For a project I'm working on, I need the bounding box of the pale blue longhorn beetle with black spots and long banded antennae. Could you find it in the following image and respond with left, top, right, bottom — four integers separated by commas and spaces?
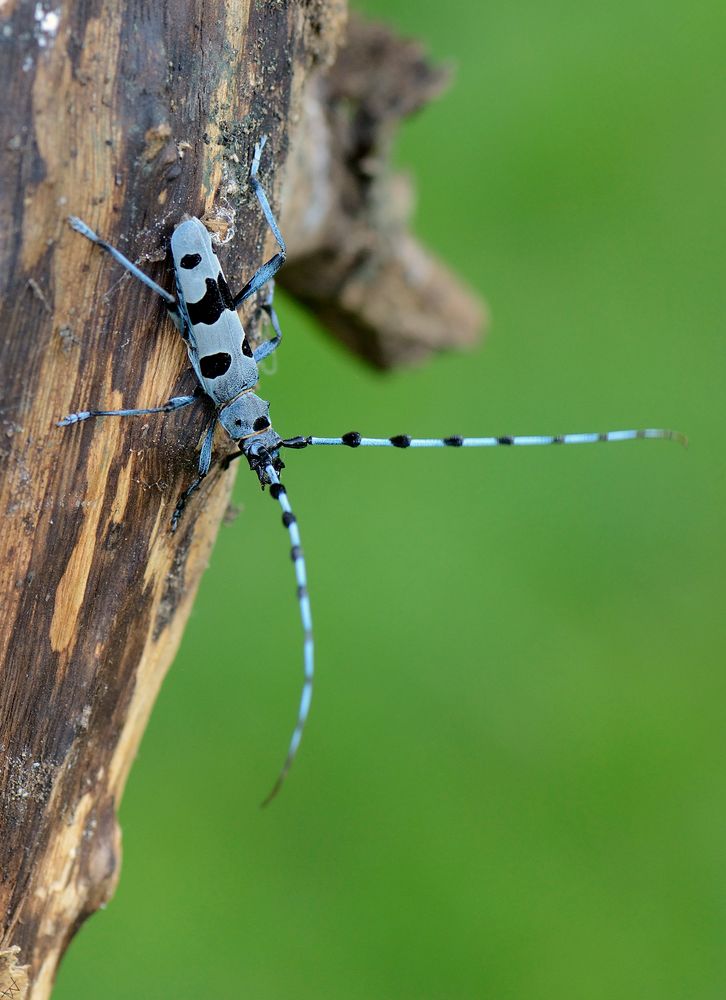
58, 136, 686, 805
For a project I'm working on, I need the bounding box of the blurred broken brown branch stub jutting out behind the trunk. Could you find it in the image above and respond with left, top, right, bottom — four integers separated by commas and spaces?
280, 17, 486, 368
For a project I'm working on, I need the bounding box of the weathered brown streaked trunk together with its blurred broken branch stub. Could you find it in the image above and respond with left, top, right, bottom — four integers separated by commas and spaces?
0, 0, 490, 1000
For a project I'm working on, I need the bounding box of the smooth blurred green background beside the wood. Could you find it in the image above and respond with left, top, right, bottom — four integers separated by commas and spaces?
55, 0, 726, 1000
